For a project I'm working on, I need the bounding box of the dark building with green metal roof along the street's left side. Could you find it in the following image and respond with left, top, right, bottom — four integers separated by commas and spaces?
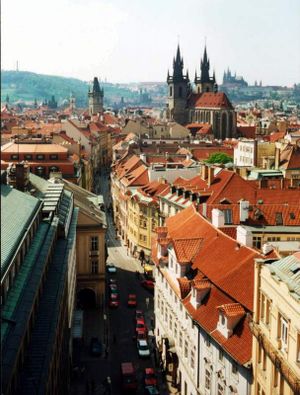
1, 169, 78, 394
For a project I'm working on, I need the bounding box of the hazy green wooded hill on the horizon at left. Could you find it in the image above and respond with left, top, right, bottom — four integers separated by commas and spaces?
1, 70, 137, 107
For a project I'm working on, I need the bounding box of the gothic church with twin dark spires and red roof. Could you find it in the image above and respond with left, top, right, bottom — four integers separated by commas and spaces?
167, 45, 236, 140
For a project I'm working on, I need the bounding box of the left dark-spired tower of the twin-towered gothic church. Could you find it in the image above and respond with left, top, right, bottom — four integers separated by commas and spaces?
167, 44, 191, 124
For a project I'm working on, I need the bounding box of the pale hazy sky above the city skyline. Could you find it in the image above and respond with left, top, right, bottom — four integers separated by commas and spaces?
1, 0, 300, 86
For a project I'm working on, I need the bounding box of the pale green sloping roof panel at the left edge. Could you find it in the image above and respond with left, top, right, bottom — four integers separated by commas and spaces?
1, 185, 41, 276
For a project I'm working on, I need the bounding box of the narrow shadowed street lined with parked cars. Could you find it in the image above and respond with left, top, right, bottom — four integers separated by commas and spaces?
71, 173, 166, 395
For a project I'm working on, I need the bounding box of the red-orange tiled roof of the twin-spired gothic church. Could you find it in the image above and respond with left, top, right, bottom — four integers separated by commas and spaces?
188, 92, 233, 110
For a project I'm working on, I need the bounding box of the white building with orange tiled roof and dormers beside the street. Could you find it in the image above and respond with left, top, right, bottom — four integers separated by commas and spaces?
152, 206, 261, 395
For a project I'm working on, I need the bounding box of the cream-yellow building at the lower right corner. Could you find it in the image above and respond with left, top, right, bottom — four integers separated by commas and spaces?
251, 253, 300, 395
